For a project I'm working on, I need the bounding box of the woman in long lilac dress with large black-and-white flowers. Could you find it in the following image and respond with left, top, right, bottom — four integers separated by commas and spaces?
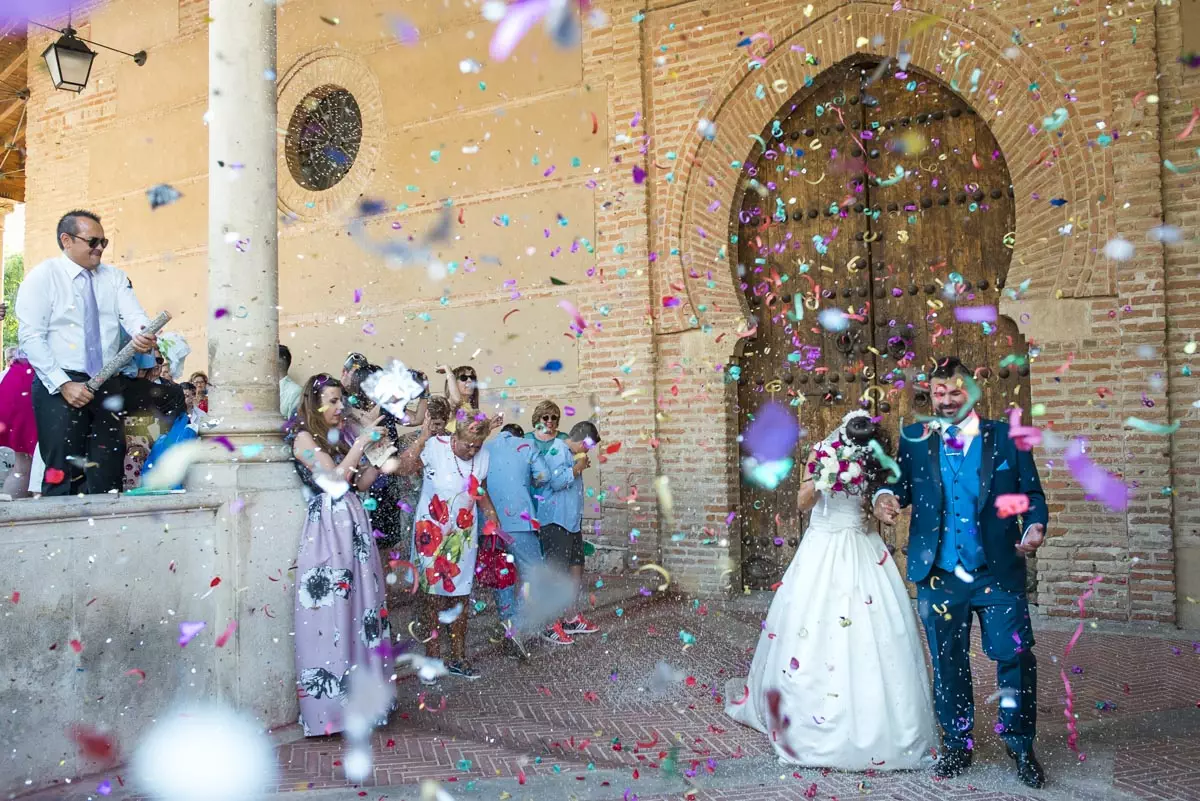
290, 374, 392, 737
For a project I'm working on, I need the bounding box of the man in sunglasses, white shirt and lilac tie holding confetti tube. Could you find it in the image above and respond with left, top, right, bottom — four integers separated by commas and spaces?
16, 210, 156, 495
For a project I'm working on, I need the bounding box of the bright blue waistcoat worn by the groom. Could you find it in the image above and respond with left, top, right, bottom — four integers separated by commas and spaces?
935, 435, 988, 572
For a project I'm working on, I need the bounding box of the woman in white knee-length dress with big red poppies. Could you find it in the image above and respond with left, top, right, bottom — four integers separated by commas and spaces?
397, 415, 498, 680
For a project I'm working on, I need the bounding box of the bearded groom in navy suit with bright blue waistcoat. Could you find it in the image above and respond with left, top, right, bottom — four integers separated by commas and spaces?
875, 357, 1048, 788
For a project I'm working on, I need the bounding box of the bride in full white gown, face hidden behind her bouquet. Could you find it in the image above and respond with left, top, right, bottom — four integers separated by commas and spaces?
725, 411, 937, 770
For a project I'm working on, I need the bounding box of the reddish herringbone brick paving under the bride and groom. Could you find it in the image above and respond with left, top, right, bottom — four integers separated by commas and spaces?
11, 588, 1200, 801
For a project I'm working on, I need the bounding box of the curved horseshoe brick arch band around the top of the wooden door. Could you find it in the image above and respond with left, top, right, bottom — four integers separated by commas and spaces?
660, 2, 1115, 359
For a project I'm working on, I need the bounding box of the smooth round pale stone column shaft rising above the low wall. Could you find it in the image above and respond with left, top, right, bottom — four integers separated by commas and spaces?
209, 0, 282, 450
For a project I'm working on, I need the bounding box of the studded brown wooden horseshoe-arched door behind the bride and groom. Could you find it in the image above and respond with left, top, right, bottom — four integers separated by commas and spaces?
731, 59, 1028, 589
